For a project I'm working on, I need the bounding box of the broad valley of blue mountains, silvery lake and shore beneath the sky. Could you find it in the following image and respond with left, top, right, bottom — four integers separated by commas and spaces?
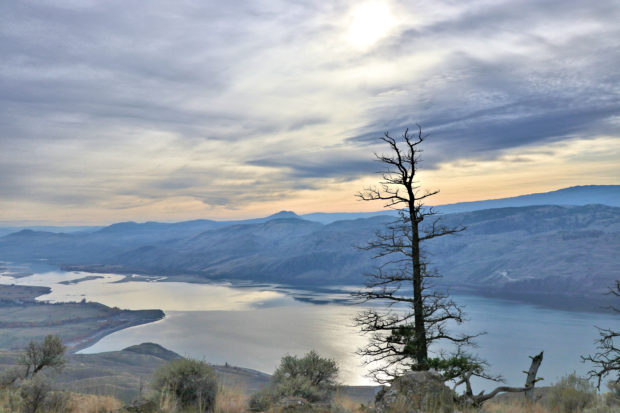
0, 188, 620, 408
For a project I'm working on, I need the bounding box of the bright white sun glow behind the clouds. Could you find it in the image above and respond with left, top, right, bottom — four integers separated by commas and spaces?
348, 1, 395, 49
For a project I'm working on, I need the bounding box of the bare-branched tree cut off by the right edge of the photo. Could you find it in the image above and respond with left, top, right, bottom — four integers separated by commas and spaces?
581, 280, 620, 390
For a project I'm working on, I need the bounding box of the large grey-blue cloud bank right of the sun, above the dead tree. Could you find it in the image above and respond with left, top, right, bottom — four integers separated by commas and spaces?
346, 1, 620, 160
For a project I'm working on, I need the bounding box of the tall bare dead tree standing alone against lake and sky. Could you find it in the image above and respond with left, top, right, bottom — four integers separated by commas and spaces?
353, 125, 482, 383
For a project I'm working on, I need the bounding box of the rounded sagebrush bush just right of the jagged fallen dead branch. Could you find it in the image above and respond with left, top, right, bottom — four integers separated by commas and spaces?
549, 373, 597, 413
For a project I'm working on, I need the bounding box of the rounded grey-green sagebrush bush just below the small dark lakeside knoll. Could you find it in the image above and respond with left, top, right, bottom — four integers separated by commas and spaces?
152, 359, 217, 412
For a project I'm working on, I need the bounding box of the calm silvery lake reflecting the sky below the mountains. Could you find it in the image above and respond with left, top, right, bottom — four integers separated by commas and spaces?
0, 264, 620, 390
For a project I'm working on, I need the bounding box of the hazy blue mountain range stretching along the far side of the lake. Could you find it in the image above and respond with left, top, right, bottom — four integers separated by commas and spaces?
0, 186, 620, 297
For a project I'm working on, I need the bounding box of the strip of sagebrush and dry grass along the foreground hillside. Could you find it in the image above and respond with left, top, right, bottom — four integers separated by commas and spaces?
0, 336, 620, 413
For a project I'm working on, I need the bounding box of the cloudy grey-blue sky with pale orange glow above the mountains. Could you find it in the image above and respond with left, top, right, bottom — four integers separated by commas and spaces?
0, 0, 620, 224
